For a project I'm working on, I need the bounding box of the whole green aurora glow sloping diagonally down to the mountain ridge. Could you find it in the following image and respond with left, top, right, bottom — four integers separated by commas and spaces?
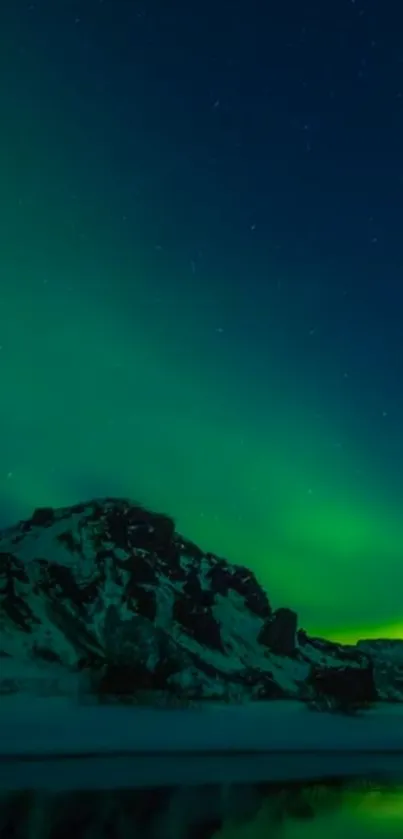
0, 4, 403, 640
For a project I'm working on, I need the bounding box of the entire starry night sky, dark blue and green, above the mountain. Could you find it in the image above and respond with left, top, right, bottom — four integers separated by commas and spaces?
0, 0, 403, 640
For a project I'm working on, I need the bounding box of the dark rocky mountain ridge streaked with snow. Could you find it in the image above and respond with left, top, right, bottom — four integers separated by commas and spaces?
0, 498, 403, 702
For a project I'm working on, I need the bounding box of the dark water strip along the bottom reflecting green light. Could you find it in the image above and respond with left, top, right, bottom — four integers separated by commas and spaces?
0, 780, 403, 839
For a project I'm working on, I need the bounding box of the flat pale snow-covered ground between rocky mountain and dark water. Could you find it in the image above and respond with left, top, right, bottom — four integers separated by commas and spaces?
0, 697, 403, 790
